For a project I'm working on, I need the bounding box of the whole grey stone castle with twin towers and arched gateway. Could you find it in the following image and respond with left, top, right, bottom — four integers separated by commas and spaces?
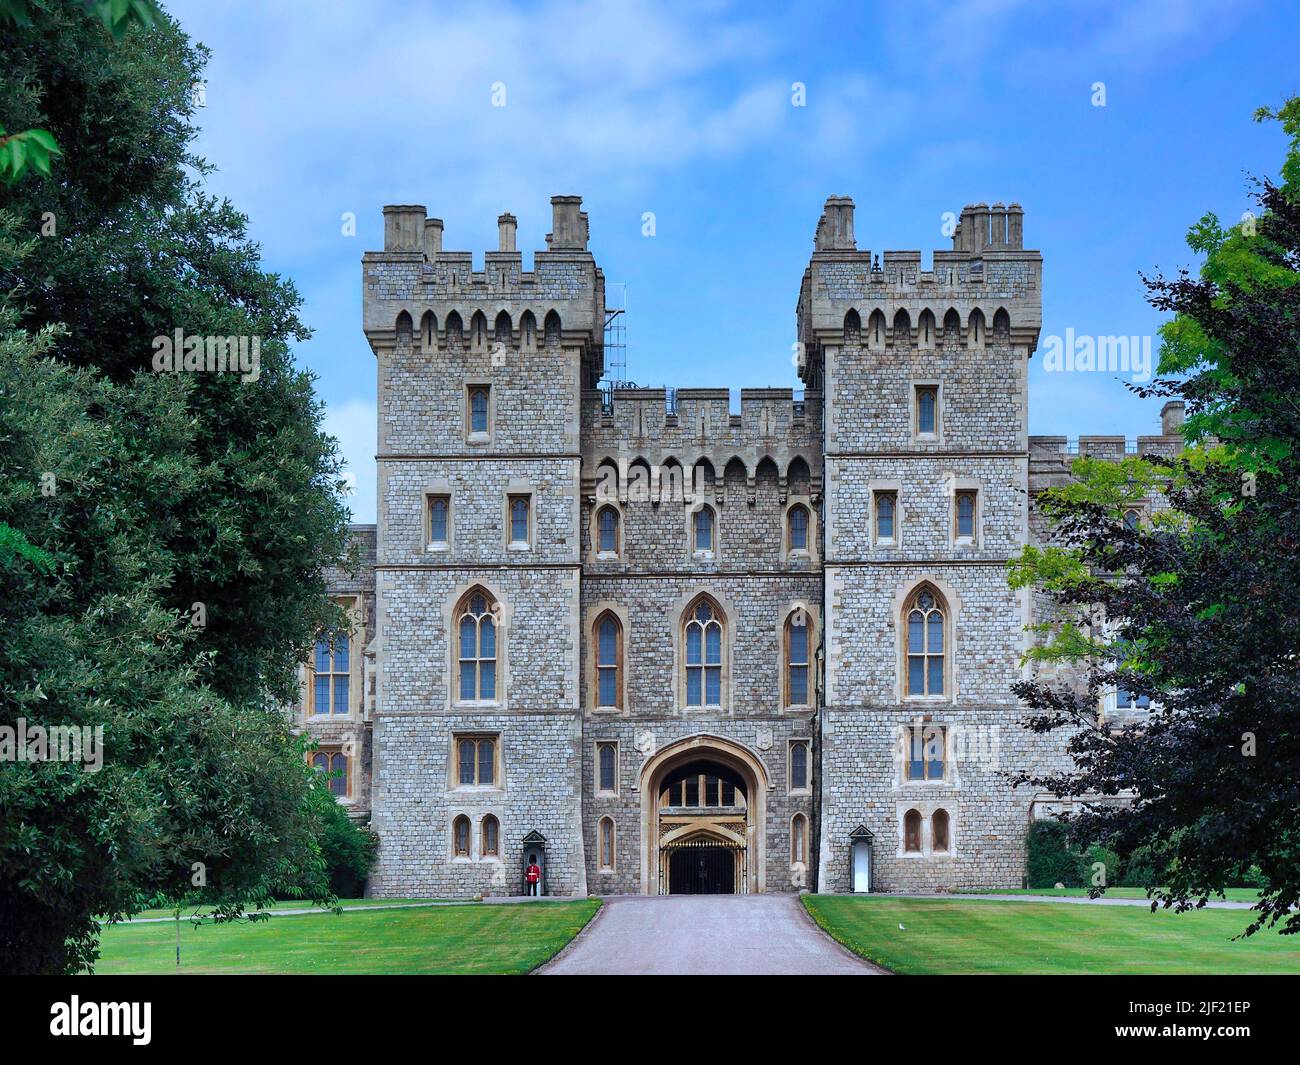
299, 196, 1182, 897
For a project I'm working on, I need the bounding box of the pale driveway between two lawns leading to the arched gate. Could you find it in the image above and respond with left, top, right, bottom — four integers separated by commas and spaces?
540, 895, 881, 975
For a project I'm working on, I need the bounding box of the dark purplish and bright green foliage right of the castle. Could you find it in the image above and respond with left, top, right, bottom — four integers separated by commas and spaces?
1010, 99, 1300, 932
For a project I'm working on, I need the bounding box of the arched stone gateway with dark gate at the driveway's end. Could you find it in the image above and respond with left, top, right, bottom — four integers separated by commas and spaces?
640, 736, 771, 895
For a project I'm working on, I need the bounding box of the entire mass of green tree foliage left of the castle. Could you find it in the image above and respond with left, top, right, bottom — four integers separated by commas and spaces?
0, 3, 347, 971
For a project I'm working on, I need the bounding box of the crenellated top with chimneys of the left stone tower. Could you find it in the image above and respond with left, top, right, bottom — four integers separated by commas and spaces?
361, 196, 605, 384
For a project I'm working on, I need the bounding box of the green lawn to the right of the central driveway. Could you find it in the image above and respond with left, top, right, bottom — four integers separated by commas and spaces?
803, 895, 1300, 974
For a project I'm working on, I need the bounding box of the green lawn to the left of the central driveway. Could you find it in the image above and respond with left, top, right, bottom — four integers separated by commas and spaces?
95, 899, 601, 974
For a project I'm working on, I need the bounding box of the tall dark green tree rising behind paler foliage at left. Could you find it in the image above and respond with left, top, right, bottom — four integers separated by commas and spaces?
0, 4, 347, 700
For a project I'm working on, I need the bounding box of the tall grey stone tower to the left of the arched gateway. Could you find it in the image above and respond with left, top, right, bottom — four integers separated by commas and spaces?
361, 196, 605, 896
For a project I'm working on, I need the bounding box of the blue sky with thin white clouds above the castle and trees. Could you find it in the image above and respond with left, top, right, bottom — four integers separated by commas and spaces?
164, 0, 1300, 521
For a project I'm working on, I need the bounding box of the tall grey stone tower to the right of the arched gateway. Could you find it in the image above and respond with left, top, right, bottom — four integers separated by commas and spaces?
798, 196, 1041, 891
